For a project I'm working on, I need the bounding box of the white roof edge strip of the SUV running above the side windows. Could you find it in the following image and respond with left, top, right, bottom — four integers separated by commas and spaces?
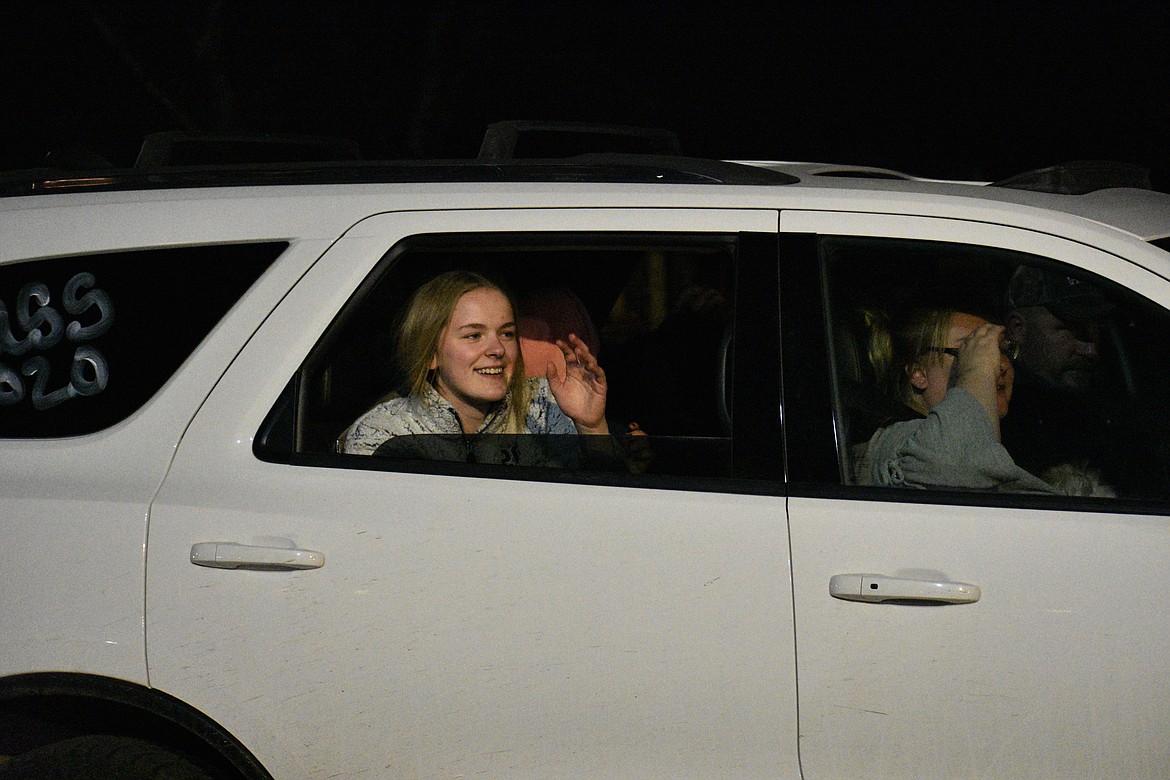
0, 177, 1170, 262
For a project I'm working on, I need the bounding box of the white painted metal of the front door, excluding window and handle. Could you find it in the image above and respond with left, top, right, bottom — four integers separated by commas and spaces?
780, 212, 1170, 778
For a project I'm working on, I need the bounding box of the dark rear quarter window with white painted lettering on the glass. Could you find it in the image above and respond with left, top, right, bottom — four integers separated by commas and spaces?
0, 242, 288, 439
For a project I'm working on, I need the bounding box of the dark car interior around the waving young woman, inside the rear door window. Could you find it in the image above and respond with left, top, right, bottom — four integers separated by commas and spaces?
261, 234, 735, 476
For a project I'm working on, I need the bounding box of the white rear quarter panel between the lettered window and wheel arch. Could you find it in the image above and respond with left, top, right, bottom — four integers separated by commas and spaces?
0, 229, 324, 684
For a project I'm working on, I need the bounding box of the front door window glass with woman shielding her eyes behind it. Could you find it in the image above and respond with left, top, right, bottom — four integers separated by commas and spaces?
821, 237, 1170, 501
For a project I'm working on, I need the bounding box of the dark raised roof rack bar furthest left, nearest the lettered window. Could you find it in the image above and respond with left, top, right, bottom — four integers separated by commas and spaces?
135, 131, 362, 170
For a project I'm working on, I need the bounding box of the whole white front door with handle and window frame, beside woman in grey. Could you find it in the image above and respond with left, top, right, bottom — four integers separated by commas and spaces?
782, 212, 1170, 778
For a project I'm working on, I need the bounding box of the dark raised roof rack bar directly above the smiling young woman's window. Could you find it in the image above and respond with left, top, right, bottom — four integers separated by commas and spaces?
477, 119, 682, 160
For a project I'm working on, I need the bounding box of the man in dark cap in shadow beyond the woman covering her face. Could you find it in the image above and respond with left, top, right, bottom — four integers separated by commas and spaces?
1002, 265, 1166, 497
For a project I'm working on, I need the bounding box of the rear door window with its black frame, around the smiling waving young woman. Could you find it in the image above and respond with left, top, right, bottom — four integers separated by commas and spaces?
256, 234, 775, 484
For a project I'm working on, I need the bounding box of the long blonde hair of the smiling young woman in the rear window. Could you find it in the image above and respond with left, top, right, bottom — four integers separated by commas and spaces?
398, 270, 529, 434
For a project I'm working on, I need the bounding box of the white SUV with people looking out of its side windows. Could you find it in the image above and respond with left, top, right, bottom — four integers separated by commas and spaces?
0, 132, 1170, 779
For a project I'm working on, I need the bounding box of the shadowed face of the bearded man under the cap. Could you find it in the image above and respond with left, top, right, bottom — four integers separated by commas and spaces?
1007, 306, 1101, 389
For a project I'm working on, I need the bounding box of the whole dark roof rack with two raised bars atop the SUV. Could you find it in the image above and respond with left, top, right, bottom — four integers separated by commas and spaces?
0, 122, 799, 196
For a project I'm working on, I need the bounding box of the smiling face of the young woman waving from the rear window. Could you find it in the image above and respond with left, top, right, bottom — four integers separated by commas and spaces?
431, 288, 519, 417
